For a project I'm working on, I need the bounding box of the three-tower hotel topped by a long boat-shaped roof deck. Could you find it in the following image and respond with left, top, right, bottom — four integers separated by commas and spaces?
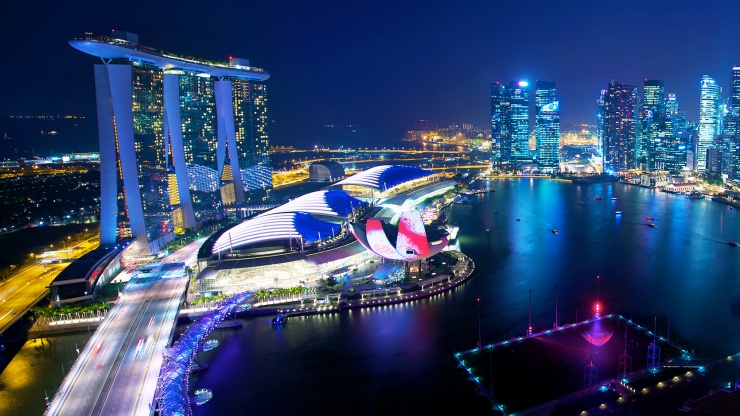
69, 31, 272, 254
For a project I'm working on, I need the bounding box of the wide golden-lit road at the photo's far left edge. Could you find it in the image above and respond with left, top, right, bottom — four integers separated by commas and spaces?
0, 236, 98, 334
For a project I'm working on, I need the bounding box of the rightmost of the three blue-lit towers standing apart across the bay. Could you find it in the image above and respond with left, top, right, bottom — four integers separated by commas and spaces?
535, 81, 560, 173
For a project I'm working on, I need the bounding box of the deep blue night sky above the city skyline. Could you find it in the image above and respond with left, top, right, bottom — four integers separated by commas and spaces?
0, 0, 740, 147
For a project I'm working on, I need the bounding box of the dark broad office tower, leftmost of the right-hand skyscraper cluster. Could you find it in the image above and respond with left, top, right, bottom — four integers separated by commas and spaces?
601, 81, 637, 174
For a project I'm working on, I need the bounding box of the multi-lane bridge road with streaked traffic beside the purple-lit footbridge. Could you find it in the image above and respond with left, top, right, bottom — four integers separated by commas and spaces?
47, 239, 205, 415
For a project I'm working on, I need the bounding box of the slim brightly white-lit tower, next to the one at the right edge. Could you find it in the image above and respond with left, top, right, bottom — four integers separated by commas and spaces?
696, 75, 721, 173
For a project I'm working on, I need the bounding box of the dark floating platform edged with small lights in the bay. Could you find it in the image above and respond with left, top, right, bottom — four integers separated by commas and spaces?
455, 315, 704, 415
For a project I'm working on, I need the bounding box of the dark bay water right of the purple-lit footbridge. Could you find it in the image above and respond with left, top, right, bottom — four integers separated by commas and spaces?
190, 179, 740, 415
